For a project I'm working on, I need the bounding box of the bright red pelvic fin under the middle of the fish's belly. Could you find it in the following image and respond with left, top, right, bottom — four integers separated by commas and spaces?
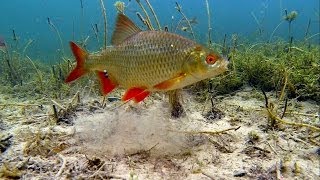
122, 87, 150, 103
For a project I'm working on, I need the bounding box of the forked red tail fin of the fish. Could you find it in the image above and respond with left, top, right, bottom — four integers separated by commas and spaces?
65, 41, 88, 83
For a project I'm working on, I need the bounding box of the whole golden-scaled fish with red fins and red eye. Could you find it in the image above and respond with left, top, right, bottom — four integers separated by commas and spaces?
65, 13, 228, 103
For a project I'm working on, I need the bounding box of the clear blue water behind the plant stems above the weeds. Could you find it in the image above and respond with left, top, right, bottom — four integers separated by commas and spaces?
0, 0, 320, 63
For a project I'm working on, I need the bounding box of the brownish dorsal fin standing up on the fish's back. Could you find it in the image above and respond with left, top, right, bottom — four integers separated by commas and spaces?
111, 13, 141, 45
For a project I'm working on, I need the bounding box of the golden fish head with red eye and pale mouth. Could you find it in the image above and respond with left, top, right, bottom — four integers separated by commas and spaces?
183, 46, 229, 83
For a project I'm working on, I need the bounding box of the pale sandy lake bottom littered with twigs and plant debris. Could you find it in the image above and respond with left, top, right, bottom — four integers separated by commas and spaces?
0, 87, 320, 179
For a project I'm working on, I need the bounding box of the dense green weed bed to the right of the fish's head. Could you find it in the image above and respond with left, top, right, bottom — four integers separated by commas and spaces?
191, 38, 320, 102
